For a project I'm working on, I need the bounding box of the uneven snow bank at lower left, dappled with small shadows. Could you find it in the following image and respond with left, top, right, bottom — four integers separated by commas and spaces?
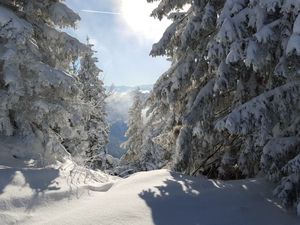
0, 156, 118, 225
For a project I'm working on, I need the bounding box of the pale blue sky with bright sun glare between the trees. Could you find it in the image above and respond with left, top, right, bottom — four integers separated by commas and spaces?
66, 0, 170, 86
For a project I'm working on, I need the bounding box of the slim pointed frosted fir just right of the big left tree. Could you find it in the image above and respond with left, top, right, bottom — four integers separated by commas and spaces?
78, 39, 108, 168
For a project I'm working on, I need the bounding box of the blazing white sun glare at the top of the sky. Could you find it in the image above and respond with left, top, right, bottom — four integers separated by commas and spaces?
118, 0, 170, 43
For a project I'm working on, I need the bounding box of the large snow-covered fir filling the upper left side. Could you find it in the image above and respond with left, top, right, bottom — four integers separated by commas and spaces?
0, 0, 106, 165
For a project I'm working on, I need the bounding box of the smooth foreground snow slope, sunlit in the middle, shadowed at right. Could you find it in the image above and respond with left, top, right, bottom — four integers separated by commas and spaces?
0, 168, 300, 225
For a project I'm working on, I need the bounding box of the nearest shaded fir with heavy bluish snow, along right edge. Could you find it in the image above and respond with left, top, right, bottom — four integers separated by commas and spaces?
210, 1, 300, 209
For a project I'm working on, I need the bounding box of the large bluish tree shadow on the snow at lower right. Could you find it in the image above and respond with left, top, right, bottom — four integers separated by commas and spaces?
139, 173, 299, 225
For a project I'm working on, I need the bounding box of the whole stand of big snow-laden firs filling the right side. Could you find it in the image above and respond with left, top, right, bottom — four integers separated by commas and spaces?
120, 0, 300, 211
